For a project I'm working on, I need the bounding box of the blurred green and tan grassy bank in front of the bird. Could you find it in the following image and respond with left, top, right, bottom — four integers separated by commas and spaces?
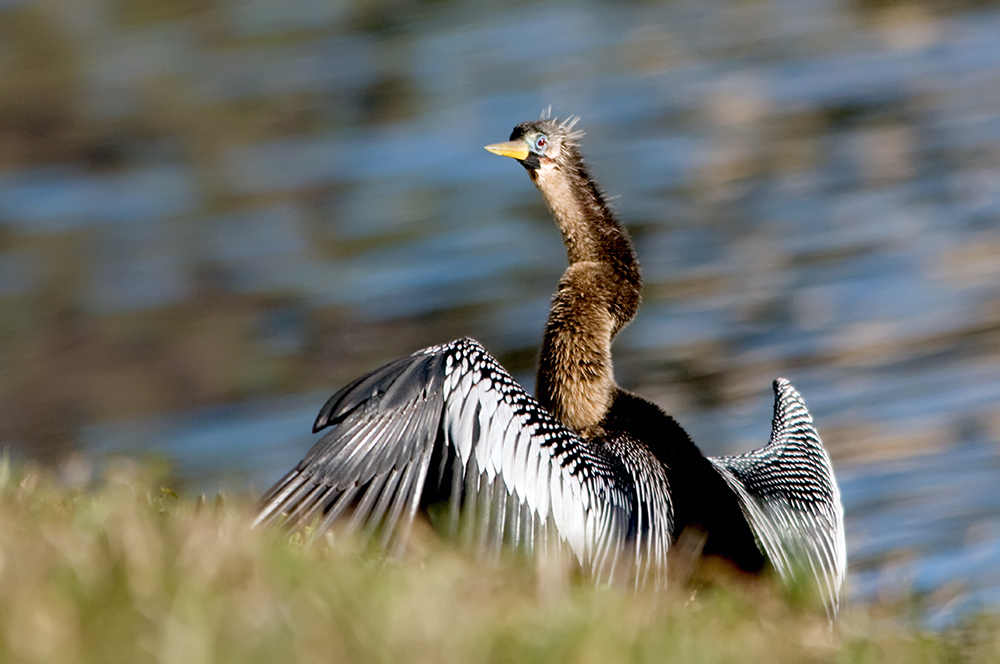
0, 456, 1000, 664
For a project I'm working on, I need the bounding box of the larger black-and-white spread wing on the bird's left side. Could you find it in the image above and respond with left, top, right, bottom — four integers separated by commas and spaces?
254, 339, 672, 578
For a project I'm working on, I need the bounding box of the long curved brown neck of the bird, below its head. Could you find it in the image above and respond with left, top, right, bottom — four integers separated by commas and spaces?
531, 153, 642, 434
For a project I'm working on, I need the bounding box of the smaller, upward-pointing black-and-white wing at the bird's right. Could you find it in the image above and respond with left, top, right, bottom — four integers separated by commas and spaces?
709, 378, 847, 617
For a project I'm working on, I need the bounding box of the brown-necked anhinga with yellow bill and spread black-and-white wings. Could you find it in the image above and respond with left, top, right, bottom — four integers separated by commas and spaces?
254, 114, 847, 619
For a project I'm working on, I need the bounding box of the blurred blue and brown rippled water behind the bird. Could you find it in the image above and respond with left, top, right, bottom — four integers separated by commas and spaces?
0, 0, 1000, 624
